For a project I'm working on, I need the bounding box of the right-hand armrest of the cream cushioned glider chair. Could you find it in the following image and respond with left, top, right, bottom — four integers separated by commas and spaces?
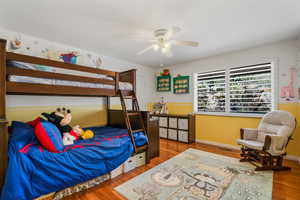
263, 135, 287, 155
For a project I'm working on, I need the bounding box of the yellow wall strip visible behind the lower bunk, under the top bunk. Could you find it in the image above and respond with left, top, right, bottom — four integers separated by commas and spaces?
6, 105, 107, 127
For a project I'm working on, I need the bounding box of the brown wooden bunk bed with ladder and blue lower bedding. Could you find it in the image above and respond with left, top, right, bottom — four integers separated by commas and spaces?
0, 39, 149, 199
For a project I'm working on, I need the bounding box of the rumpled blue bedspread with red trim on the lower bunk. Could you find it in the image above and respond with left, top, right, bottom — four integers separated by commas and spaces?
1, 124, 147, 200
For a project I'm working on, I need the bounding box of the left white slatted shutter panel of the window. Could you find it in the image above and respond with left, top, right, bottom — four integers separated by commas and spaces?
196, 70, 225, 112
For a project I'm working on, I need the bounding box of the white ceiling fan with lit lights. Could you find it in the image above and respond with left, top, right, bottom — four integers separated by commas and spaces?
137, 27, 199, 57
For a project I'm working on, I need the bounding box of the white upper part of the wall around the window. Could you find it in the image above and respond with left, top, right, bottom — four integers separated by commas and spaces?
156, 40, 298, 103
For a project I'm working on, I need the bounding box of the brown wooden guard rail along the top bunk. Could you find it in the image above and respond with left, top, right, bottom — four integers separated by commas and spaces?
0, 40, 136, 96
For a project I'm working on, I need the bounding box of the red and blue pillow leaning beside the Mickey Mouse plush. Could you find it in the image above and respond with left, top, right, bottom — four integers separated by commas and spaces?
34, 119, 64, 153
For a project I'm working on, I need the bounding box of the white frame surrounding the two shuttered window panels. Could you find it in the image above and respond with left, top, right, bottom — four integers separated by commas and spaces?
193, 61, 279, 118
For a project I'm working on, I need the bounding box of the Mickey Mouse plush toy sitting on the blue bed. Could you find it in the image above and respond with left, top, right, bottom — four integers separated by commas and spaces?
42, 108, 94, 145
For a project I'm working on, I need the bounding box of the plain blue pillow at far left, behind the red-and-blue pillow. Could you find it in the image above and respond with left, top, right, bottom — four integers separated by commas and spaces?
9, 121, 38, 151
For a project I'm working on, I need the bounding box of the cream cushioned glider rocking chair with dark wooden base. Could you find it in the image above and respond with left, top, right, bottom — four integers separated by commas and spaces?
237, 111, 296, 170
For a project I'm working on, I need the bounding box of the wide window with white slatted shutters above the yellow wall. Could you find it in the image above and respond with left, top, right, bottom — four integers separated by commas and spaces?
195, 63, 274, 114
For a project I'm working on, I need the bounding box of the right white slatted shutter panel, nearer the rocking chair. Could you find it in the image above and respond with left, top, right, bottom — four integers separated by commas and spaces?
229, 63, 272, 113
